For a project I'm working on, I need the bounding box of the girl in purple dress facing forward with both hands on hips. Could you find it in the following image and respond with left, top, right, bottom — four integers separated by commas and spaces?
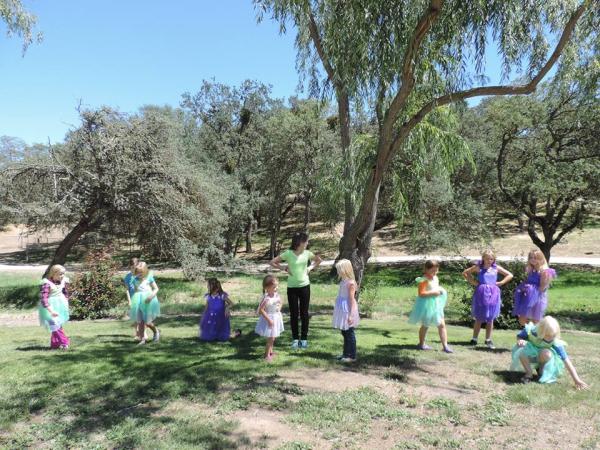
463, 250, 513, 349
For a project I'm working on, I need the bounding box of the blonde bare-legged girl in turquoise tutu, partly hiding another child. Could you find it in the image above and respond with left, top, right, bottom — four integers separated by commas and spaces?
129, 261, 160, 345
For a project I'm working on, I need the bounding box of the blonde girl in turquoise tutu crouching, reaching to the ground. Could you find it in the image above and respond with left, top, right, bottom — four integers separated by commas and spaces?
511, 316, 588, 390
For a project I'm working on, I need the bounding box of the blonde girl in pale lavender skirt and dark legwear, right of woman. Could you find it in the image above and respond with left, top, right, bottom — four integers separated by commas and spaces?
333, 259, 359, 362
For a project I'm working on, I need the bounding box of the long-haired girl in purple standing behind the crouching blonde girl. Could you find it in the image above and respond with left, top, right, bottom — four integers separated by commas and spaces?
513, 249, 556, 326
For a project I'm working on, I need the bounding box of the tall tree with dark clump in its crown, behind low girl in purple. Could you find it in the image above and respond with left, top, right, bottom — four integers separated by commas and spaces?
181, 80, 282, 256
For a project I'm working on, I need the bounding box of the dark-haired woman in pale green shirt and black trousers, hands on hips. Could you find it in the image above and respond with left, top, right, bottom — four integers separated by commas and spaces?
271, 233, 321, 348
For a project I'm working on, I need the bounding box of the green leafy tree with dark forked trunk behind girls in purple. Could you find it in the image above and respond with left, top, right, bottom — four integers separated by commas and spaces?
490, 88, 600, 260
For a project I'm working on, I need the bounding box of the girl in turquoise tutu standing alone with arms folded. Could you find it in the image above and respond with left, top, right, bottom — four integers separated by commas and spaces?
408, 260, 454, 353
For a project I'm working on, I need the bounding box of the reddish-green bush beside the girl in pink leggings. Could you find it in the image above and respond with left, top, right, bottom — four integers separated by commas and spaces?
69, 249, 124, 320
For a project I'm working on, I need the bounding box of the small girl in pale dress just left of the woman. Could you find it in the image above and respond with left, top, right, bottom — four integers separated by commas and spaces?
254, 275, 283, 362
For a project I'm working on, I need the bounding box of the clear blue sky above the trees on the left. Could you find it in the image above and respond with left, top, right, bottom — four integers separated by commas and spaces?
0, 0, 516, 144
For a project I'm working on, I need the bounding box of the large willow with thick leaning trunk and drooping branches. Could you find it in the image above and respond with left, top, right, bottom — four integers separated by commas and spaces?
254, 0, 599, 280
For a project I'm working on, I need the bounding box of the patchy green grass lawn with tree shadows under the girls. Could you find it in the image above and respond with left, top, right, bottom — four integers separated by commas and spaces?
0, 269, 600, 449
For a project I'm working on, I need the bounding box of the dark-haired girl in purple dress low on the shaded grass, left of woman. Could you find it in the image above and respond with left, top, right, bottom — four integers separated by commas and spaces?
200, 278, 233, 342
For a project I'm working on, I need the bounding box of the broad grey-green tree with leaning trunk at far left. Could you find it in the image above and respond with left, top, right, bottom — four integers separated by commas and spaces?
0, 108, 226, 274
